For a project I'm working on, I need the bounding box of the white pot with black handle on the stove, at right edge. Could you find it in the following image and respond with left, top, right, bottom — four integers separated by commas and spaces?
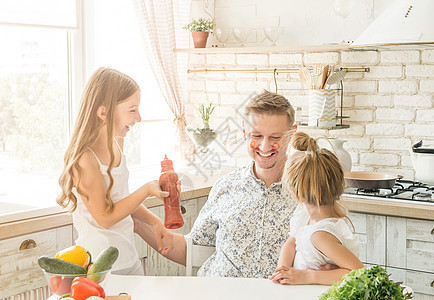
410, 141, 434, 185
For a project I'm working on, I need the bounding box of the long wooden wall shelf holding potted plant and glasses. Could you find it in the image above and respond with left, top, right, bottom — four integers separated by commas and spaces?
173, 44, 351, 54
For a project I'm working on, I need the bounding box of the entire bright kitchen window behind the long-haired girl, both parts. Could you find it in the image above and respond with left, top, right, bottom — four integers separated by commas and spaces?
0, 0, 177, 223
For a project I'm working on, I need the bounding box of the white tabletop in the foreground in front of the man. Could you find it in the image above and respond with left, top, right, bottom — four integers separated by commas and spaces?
104, 274, 330, 300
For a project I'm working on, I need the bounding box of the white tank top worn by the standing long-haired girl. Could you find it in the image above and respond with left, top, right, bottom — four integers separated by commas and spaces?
72, 140, 139, 271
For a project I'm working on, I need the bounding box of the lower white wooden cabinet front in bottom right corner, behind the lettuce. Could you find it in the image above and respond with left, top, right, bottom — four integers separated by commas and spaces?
386, 267, 434, 300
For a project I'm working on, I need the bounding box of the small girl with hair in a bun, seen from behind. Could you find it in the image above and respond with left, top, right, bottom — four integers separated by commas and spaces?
270, 132, 363, 285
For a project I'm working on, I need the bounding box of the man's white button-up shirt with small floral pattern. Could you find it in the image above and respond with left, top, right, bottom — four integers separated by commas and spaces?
188, 164, 297, 278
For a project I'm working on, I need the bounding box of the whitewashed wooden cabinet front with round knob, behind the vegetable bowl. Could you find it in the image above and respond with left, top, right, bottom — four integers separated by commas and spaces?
0, 225, 72, 299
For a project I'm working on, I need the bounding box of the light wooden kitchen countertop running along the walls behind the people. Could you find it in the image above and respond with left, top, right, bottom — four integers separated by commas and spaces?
0, 169, 434, 240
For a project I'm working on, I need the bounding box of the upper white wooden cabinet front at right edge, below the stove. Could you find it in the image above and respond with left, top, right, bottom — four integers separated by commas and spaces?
387, 217, 434, 273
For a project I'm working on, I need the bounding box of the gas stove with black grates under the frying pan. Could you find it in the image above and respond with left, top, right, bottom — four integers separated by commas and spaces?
343, 179, 434, 204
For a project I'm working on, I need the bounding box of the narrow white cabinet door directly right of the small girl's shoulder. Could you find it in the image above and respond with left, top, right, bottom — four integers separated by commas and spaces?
349, 213, 386, 266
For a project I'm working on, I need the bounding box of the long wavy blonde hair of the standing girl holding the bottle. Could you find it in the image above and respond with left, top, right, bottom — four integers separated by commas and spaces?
57, 67, 139, 212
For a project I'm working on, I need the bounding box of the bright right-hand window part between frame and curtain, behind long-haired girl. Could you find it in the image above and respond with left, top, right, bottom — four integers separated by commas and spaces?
86, 0, 177, 190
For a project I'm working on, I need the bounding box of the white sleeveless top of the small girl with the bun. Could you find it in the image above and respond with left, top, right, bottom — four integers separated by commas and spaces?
290, 203, 359, 270
